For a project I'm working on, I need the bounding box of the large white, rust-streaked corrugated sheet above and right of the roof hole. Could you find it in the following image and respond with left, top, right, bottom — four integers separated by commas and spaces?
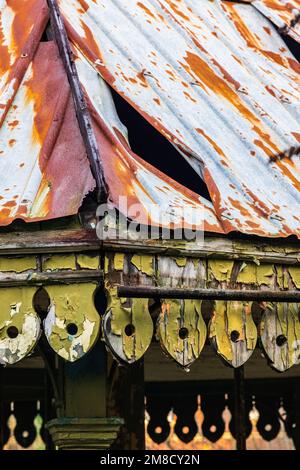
59, 0, 300, 236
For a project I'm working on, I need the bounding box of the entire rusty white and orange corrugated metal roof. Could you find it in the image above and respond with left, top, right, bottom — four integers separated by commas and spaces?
0, 0, 300, 236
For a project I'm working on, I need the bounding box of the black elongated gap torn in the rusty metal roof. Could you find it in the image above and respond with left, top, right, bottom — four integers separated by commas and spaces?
111, 89, 211, 201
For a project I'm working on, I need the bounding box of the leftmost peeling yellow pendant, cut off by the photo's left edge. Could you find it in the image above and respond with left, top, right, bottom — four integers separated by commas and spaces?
0, 287, 40, 364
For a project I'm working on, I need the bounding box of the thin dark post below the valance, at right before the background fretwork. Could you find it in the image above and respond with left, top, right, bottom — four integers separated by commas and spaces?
234, 366, 246, 450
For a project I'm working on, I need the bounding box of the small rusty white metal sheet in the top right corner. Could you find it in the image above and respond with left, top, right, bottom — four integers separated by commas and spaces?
252, 0, 300, 42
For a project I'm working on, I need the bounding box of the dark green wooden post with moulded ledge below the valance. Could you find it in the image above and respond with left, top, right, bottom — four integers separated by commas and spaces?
47, 342, 122, 450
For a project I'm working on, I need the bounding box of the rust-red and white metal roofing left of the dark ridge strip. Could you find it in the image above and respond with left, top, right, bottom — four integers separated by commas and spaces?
0, 0, 94, 225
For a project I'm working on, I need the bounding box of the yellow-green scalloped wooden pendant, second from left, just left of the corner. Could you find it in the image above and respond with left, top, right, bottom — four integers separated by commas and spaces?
44, 283, 100, 362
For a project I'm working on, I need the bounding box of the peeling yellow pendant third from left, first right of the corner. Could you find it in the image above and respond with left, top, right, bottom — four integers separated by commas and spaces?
102, 289, 153, 364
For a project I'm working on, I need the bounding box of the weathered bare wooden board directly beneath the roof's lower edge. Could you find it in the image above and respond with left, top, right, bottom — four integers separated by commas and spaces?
0, 228, 300, 265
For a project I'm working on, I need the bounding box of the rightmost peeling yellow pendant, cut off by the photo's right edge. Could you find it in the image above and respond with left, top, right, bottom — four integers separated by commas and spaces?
260, 303, 300, 372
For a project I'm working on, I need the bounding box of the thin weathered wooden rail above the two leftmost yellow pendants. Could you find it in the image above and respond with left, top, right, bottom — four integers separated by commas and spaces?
0, 269, 103, 287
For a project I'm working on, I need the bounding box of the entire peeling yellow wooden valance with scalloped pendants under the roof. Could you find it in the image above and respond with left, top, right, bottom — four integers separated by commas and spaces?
0, 233, 300, 371
